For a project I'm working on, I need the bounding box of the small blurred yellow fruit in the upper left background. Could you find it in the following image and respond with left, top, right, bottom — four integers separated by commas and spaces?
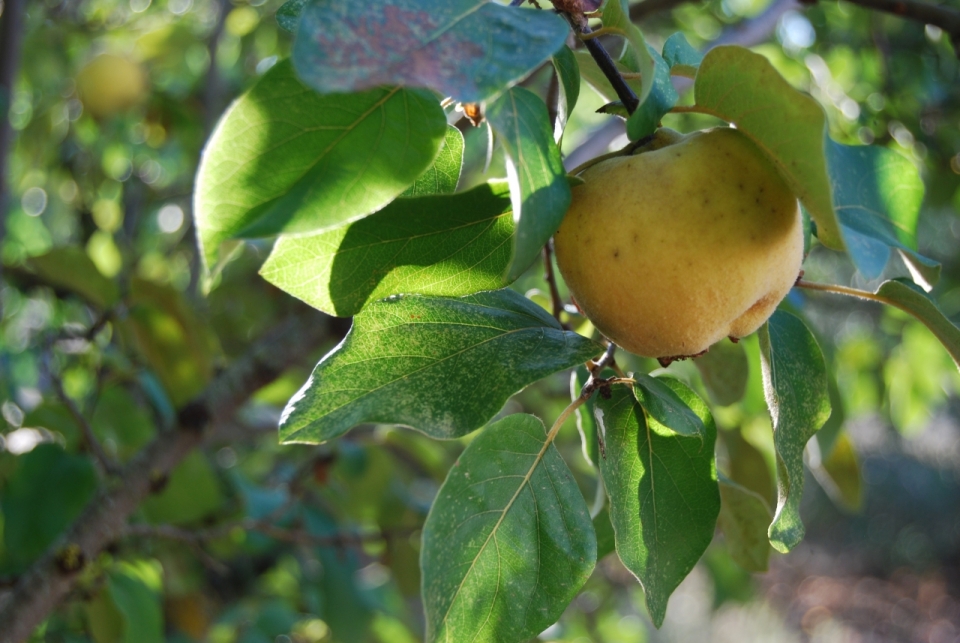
77, 54, 147, 118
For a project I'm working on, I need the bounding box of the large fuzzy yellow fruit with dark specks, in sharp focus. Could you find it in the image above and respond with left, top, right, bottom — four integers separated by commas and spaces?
554, 128, 803, 358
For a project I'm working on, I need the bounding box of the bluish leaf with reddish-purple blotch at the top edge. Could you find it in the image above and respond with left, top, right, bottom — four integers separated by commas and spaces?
293, 0, 570, 103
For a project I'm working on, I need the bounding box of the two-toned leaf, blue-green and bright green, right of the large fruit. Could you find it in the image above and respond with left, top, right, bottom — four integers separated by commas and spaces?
825, 139, 940, 290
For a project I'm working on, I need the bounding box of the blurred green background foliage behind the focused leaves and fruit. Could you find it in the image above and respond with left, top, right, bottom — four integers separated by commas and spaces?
0, 0, 960, 643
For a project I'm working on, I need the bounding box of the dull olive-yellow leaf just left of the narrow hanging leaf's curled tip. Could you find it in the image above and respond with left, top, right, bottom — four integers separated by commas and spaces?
717, 475, 773, 572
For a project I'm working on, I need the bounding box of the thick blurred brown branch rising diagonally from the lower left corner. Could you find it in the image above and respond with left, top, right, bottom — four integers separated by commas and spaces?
0, 313, 340, 643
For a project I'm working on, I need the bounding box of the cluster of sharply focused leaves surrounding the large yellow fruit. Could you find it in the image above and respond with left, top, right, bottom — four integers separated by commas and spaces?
189, 0, 960, 641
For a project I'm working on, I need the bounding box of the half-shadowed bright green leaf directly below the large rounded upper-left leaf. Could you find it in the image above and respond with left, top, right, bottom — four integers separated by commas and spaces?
260, 181, 513, 317
